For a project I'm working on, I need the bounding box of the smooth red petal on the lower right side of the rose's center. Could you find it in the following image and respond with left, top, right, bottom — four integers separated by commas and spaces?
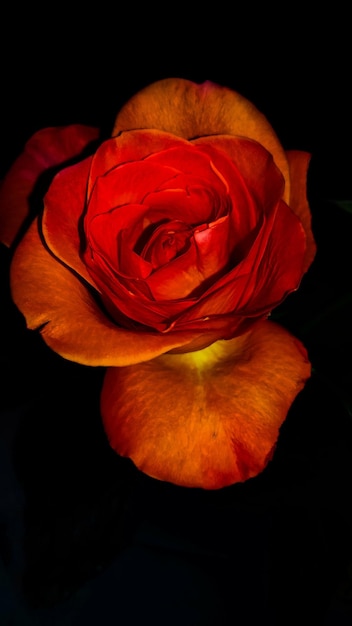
177, 202, 305, 327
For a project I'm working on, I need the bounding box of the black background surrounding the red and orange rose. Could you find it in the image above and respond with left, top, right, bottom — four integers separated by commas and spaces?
0, 11, 352, 626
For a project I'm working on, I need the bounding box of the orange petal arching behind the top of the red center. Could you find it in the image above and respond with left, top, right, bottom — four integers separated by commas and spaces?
112, 78, 290, 201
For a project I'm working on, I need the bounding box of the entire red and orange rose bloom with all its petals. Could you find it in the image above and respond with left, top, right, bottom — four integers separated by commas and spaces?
0, 79, 315, 489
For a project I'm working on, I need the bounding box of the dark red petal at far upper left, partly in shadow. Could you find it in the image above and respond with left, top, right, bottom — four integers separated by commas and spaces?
0, 124, 99, 246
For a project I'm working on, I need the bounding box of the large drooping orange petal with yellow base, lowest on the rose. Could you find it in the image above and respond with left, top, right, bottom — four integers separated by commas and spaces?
101, 321, 310, 489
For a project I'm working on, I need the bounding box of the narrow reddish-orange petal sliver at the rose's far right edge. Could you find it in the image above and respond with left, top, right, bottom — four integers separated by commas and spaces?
286, 150, 316, 271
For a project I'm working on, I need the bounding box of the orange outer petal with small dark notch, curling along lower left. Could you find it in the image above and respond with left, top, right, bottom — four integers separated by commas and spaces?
11, 220, 221, 366
